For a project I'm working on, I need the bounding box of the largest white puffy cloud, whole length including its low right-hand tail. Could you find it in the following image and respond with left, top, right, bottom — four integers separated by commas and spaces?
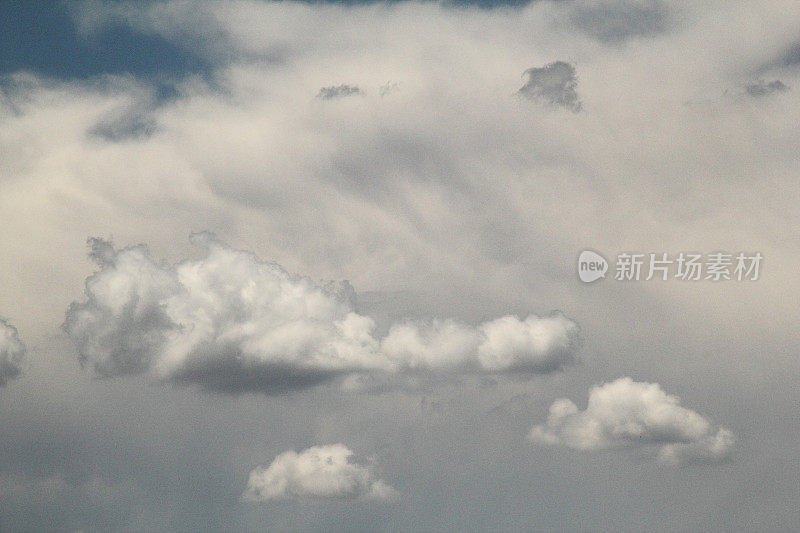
64, 233, 580, 393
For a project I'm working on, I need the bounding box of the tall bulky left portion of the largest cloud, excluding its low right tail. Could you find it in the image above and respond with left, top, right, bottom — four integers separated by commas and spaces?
64, 234, 390, 391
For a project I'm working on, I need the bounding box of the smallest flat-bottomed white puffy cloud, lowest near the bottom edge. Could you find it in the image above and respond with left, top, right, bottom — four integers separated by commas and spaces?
242, 444, 397, 502
